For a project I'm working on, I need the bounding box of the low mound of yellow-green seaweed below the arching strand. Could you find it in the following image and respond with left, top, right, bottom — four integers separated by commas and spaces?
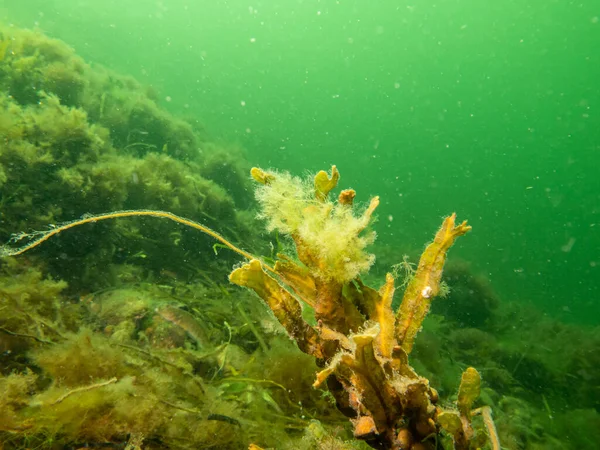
0, 259, 354, 449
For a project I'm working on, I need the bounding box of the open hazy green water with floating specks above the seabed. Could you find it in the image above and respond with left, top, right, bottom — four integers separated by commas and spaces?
0, 0, 600, 324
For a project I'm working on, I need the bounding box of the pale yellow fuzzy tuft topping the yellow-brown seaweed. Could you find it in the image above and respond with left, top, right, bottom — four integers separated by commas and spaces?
252, 167, 379, 283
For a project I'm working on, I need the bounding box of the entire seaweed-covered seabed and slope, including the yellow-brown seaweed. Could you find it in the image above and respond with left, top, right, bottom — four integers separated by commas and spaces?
0, 22, 600, 450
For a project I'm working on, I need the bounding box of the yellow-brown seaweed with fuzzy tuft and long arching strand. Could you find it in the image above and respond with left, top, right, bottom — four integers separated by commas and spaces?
2, 166, 498, 450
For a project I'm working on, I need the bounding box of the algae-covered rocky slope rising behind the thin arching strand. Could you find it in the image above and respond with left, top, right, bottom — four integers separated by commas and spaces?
0, 27, 253, 289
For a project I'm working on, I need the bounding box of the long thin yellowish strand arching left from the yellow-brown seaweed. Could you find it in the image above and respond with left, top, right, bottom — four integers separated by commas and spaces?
0, 209, 275, 272
